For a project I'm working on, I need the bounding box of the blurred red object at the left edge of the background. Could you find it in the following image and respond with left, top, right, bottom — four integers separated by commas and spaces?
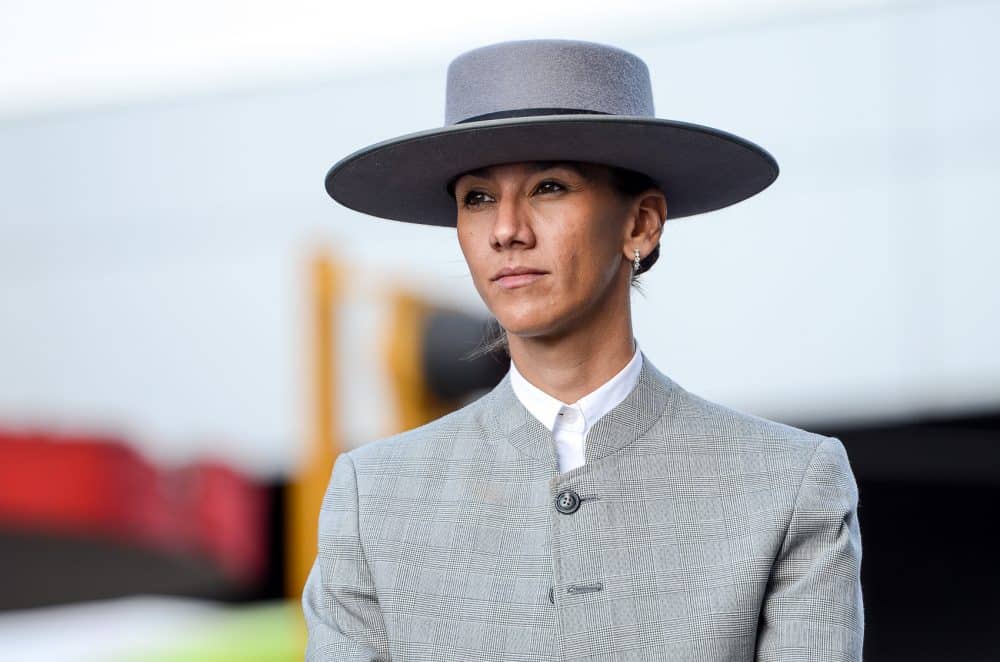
0, 429, 268, 583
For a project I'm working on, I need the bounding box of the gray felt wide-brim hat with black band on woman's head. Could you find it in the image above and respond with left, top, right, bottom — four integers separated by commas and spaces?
326, 39, 778, 226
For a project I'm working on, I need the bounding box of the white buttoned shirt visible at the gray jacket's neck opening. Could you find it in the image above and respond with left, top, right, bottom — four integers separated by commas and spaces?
510, 342, 642, 472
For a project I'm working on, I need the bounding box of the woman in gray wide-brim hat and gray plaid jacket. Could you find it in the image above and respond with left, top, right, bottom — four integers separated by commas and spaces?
303, 40, 864, 662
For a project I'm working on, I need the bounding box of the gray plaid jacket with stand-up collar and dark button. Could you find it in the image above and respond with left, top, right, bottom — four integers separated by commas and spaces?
302, 355, 864, 662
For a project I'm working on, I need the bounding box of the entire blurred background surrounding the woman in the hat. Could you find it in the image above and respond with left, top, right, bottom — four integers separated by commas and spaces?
0, 0, 1000, 662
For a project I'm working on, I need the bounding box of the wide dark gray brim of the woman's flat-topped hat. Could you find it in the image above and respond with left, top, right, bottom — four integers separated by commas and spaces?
326, 115, 778, 227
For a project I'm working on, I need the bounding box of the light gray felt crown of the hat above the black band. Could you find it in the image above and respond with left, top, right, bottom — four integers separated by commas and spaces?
445, 39, 654, 125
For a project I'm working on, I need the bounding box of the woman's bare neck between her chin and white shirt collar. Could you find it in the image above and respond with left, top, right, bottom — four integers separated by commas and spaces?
508, 316, 635, 404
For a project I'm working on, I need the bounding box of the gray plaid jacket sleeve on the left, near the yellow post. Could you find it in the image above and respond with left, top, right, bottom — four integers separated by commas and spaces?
302, 453, 389, 662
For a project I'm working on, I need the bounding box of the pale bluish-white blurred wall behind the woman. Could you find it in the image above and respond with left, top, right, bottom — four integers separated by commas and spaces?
0, 1, 1000, 473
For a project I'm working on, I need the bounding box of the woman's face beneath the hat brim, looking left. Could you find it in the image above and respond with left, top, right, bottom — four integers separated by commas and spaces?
455, 162, 631, 337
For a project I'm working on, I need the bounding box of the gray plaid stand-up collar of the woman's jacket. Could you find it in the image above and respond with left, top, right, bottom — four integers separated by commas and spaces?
484, 353, 680, 470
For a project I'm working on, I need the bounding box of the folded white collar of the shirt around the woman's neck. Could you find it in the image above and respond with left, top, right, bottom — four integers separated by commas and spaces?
510, 342, 642, 430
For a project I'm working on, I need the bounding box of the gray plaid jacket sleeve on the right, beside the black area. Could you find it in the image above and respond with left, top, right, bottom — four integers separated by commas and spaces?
756, 437, 864, 662
